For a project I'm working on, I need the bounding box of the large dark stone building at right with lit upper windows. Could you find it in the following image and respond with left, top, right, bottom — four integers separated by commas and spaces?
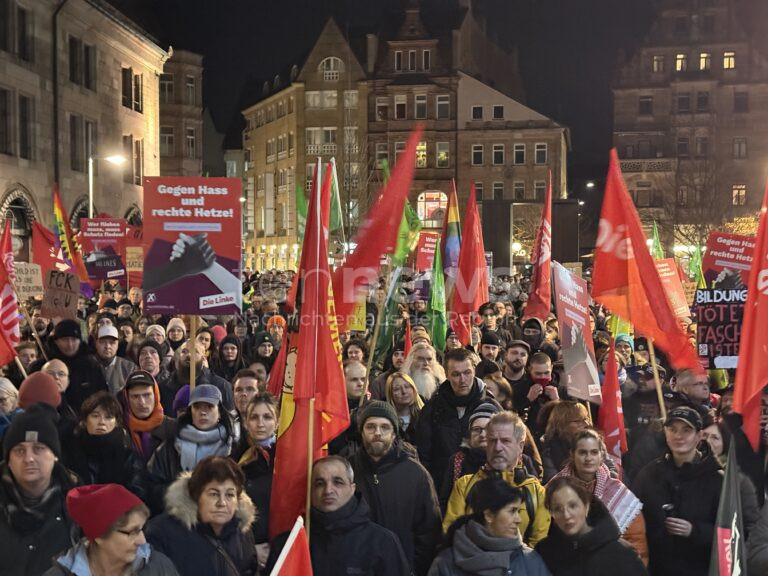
613, 0, 768, 251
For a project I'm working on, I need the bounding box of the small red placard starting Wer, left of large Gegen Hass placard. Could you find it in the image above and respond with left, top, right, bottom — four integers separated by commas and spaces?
80, 218, 126, 280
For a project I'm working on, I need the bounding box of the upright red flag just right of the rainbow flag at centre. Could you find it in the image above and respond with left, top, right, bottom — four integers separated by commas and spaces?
451, 184, 490, 346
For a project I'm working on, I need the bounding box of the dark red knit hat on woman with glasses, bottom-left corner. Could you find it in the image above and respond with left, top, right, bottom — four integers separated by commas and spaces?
67, 484, 144, 540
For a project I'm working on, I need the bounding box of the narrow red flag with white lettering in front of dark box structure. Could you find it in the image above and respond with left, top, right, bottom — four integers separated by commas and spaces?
523, 172, 552, 320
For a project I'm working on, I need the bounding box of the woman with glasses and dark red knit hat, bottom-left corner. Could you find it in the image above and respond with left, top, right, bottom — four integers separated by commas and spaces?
44, 484, 178, 576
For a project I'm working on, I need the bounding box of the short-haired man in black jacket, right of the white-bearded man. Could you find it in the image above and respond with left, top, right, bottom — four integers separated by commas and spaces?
416, 348, 490, 486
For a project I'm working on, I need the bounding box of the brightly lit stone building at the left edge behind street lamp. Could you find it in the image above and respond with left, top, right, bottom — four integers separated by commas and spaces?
0, 0, 169, 260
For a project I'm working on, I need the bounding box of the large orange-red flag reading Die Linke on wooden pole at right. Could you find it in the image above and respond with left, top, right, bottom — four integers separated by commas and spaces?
592, 149, 701, 372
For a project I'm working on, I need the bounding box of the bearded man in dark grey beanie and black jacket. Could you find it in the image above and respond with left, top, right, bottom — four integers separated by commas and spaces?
352, 400, 441, 576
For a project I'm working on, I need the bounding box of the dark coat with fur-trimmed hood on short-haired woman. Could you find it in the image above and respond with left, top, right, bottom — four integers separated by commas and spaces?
145, 472, 256, 576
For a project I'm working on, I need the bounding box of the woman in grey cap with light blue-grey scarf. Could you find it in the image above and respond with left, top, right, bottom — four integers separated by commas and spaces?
147, 384, 233, 511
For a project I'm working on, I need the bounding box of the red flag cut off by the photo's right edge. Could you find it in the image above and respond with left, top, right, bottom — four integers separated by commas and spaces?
733, 188, 768, 450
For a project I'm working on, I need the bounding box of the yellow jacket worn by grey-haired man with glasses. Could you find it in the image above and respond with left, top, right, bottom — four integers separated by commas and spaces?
443, 466, 550, 546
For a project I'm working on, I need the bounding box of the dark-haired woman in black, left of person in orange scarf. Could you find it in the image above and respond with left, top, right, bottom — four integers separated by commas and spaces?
62, 391, 149, 500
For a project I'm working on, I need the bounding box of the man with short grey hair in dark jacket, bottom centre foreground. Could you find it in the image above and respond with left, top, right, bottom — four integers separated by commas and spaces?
261, 456, 411, 576
